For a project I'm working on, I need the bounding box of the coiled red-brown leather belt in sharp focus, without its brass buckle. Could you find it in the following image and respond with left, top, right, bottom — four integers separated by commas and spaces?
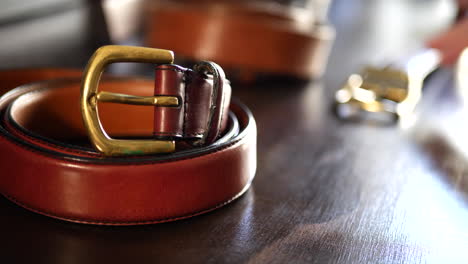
0, 46, 256, 225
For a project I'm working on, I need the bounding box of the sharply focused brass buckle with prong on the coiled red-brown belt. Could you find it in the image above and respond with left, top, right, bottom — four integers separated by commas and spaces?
80, 46, 180, 156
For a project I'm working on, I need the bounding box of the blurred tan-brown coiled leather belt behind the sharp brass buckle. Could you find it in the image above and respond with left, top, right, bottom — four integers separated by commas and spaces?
145, 0, 334, 79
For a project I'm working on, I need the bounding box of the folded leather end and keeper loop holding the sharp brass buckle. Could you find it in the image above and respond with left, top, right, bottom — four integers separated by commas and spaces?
154, 65, 231, 143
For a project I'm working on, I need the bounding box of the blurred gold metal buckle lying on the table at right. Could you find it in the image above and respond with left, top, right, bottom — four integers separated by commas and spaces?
335, 49, 440, 120
